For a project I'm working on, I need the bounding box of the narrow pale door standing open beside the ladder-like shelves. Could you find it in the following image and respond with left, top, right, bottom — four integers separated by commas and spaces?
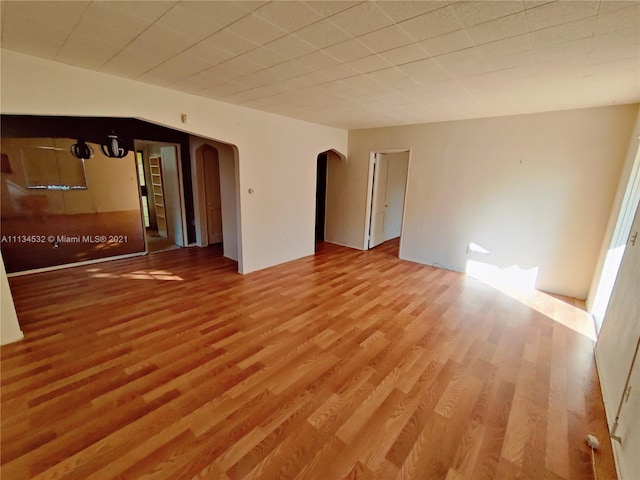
160, 146, 184, 247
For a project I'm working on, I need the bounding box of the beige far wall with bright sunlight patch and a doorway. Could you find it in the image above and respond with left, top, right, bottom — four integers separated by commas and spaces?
340, 105, 637, 298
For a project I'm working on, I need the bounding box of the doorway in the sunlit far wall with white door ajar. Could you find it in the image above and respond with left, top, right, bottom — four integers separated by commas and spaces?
365, 150, 410, 255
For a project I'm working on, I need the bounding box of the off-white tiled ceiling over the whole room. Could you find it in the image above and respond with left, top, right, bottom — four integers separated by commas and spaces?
1, 0, 640, 129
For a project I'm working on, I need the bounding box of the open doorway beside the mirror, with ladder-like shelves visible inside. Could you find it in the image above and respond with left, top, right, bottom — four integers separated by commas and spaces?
134, 140, 187, 253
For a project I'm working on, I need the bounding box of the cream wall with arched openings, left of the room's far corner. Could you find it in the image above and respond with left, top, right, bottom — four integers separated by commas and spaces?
0, 50, 348, 273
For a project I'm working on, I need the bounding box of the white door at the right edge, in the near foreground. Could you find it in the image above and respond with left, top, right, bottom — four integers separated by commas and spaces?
596, 200, 640, 479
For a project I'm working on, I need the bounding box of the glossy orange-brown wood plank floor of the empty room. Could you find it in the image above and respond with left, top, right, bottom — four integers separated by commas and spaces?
0, 242, 615, 480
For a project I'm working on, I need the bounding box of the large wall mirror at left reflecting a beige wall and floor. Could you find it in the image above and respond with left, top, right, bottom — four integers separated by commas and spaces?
0, 138, 145, 273
